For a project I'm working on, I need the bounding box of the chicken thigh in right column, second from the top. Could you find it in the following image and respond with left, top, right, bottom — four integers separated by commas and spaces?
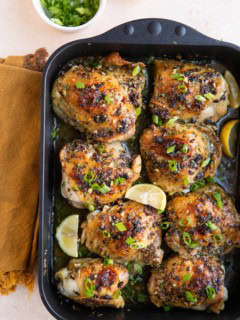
140, 123, 222, 194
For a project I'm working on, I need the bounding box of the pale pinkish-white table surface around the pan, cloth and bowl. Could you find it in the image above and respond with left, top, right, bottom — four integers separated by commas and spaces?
0, 0, 240, 320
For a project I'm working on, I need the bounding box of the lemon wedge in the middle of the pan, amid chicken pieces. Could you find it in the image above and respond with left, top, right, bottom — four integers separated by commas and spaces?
125, 183, 167, 211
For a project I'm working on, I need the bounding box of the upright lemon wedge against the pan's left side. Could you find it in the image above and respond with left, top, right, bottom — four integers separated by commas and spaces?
56, 214, 79, 258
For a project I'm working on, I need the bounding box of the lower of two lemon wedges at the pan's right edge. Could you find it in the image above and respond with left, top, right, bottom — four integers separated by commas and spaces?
220, 119, 240, 158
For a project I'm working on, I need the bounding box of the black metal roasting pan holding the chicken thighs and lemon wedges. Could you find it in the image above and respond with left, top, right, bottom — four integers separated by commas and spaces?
39, 19, 240, 320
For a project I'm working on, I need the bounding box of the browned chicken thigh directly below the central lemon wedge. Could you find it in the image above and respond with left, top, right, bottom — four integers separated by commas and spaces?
81, 201, 163, 266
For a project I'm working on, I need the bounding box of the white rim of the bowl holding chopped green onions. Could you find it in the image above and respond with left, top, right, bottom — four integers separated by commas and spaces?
32, 0, 107, 32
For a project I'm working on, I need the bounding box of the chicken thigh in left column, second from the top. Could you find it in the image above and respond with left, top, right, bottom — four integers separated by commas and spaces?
60, 140, 141, 208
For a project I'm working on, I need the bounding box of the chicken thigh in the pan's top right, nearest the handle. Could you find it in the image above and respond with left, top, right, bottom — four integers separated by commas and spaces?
150, 60, 229, 122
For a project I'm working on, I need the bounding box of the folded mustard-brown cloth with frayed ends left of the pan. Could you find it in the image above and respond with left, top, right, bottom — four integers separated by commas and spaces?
0, 49, 48, 295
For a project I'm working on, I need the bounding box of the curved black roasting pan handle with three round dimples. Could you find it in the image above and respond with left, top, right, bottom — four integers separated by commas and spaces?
94, 19, 221, 45
